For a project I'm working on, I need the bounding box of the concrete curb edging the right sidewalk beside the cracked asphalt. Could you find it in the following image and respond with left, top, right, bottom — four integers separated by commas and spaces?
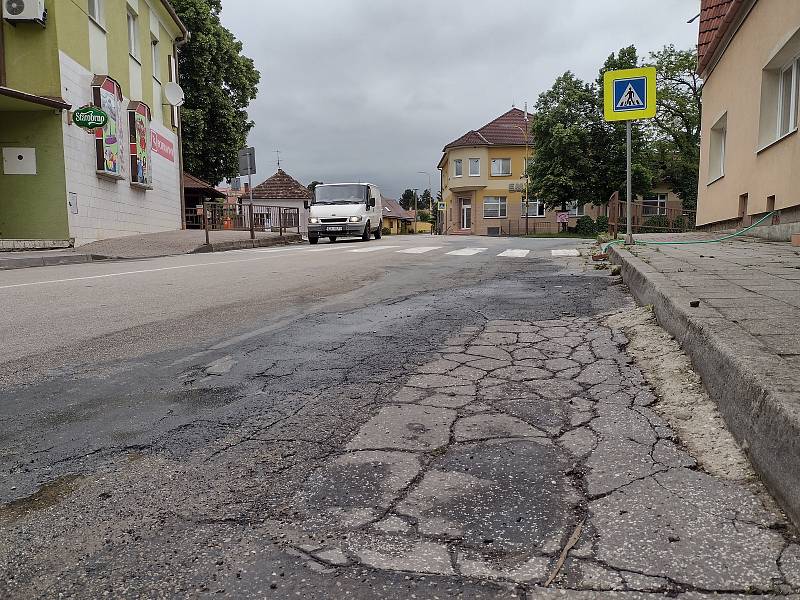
609, 246, 800, 527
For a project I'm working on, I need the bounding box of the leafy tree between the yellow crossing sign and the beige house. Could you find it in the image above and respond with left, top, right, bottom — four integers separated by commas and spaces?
649, 45, 703, 210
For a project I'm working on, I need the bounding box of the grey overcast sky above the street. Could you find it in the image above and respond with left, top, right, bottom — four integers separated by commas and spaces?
222, 0, 700, 198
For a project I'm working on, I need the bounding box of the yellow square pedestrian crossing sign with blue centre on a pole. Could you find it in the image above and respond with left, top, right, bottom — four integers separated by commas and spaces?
603, 67, 656, 121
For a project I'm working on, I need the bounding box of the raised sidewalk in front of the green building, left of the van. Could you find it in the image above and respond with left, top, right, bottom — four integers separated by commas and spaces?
0, 229, 301, 271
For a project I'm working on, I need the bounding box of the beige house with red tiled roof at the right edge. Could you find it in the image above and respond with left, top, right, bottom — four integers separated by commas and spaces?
697, 0, 800, 239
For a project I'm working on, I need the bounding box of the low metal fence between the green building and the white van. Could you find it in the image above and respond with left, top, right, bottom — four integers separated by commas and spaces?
186, 202, 300, 244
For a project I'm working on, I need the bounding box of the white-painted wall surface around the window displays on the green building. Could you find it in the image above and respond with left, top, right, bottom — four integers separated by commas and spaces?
60, 52, 181, 245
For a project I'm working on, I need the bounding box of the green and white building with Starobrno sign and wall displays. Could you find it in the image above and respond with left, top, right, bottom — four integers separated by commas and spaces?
0, 0, 189, 249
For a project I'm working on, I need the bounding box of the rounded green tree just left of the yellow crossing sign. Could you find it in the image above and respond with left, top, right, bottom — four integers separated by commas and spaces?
528, 71, 603, 230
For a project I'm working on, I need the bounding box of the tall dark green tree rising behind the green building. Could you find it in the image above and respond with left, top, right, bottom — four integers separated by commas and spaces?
172, 0, 261, 183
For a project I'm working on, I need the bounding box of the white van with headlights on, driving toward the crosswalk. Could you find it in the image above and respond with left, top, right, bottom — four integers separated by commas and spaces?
307, 183, 383, 244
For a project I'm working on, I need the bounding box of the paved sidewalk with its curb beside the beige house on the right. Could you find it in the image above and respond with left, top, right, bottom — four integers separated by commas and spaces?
609, 234, 800, 523
